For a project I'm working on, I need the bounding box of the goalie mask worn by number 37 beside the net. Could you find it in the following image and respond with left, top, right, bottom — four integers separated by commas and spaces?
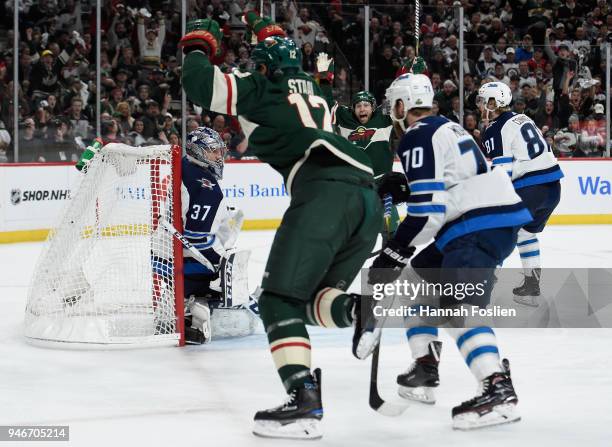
185, 127, 227, 180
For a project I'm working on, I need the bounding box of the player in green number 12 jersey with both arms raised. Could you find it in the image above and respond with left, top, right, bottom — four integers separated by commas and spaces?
181, 13, 382, 439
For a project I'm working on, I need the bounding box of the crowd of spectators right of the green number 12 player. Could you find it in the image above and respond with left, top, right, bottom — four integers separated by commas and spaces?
319, 0, 612, 157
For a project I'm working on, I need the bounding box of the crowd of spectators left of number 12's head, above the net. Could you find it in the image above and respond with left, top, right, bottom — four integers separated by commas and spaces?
0, 0, 255, 162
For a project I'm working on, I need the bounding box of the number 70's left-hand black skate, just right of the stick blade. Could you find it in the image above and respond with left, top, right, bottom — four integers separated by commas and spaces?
397, 341, 442, 405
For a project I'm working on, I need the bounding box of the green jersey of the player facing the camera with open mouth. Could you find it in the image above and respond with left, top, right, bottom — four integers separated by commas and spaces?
321, 81, 394, 177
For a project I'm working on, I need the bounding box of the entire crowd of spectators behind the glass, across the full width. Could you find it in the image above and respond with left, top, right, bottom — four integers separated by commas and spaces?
0, 0, 612, 162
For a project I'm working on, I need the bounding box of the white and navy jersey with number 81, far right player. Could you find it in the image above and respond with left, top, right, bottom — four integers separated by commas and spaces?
483, 112, 563, 189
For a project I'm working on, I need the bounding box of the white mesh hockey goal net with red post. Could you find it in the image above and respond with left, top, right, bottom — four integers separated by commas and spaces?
25, 144, 183, 347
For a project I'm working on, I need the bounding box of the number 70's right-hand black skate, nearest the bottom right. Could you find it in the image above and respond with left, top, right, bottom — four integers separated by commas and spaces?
453, 359, 521, 430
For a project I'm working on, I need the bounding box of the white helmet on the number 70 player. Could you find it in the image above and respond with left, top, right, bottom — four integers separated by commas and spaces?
383, 73, 434, 122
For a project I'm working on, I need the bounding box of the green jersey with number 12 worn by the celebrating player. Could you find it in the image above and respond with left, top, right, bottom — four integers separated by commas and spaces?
182, 51, 373, 192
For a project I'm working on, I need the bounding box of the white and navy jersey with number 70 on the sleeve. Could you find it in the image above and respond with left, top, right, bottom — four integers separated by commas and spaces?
395, 116, 532, 250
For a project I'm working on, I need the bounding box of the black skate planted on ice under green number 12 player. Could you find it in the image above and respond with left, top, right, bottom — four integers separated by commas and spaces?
253, 368, 323, 439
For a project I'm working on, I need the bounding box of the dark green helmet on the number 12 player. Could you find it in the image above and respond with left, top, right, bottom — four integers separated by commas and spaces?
251, 36, 302, 76
